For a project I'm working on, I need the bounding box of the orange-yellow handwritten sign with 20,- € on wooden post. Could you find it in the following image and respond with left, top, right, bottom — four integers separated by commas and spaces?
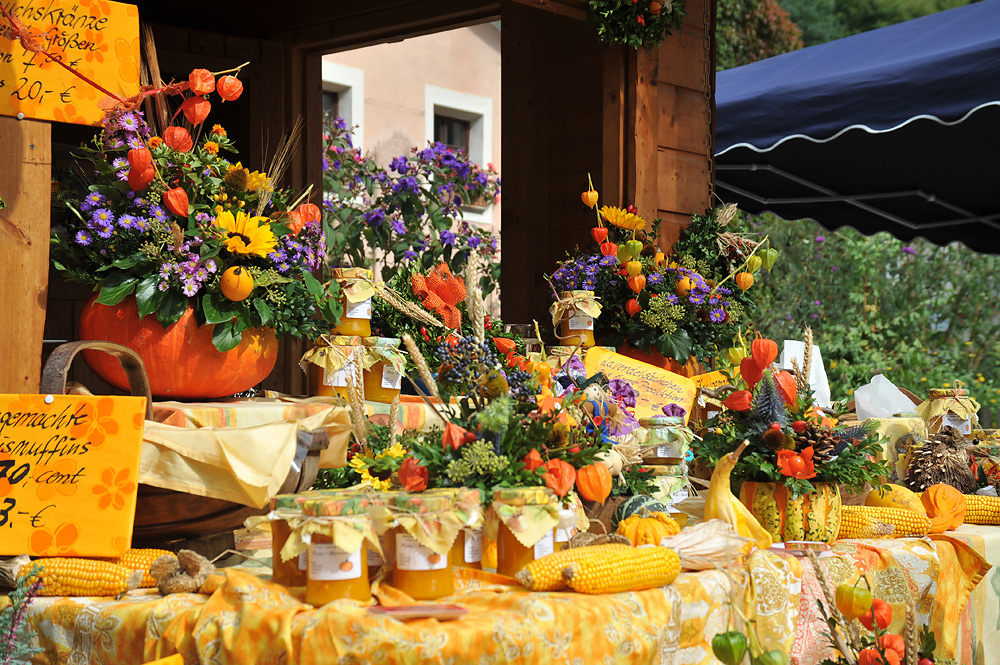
0, 0, 139, 125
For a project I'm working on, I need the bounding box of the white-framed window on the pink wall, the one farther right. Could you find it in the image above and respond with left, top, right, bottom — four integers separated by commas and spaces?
424, 85, 493, 225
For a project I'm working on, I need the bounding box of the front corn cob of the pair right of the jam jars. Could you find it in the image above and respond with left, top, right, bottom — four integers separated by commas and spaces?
563, 545, 681, 593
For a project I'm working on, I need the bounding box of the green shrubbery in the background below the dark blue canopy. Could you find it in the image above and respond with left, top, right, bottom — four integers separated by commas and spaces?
743, 215, 1000, 420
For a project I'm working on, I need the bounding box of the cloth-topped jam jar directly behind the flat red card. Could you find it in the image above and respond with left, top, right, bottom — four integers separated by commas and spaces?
385, 494, 462, 600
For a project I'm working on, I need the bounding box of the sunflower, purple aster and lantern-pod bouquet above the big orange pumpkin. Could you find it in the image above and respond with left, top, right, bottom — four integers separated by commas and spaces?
52, 69, 340, 351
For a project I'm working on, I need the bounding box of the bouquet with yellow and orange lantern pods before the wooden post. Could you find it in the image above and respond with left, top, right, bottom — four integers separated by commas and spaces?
550, 185, 777, 364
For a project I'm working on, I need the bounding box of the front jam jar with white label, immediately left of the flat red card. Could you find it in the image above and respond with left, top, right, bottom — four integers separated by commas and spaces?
299, 493, 378, 606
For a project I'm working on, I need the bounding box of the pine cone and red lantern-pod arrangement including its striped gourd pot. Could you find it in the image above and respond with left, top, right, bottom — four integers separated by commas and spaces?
691, 333, 889, 542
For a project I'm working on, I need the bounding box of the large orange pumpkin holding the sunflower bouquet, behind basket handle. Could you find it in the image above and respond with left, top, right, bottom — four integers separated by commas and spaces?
80, 296, 278, 399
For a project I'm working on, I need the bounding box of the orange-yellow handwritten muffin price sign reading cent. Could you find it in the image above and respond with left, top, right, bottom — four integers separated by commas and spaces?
0, 395, 146, 556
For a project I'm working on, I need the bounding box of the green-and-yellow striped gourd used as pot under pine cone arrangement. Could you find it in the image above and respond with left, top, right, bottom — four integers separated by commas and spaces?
740, 480, 841, 543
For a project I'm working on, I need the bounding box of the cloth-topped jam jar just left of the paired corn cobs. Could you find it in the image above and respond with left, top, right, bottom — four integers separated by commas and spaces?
487, 487, 559, 577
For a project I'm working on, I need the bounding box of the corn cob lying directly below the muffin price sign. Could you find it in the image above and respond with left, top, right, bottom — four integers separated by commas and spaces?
19, 557, 142, 596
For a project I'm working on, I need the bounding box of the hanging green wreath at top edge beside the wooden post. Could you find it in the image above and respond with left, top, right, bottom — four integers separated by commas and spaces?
587, 0, 684, 49
